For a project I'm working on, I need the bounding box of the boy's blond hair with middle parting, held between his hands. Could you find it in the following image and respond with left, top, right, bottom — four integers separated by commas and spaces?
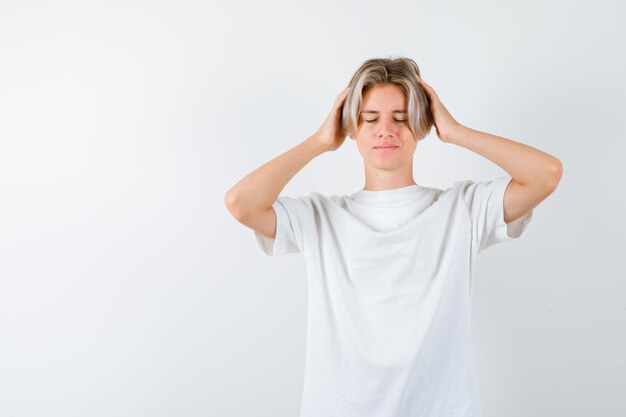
341, 57, 434, 141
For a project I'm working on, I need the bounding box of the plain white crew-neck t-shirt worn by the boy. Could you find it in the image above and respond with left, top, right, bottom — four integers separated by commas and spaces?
255, 176, 533, 417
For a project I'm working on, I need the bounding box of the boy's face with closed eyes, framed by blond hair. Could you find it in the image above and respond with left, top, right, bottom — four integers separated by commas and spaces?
353, 84, 417, 171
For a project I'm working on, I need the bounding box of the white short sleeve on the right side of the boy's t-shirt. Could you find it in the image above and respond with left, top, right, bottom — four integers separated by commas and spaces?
461, 175, 533, 253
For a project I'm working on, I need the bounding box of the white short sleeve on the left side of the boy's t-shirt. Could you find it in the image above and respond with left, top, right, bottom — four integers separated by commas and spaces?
254, 195, 317, 256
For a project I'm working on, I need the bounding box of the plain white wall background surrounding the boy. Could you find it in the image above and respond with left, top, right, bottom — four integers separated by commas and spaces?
0, 0, 626, 417
